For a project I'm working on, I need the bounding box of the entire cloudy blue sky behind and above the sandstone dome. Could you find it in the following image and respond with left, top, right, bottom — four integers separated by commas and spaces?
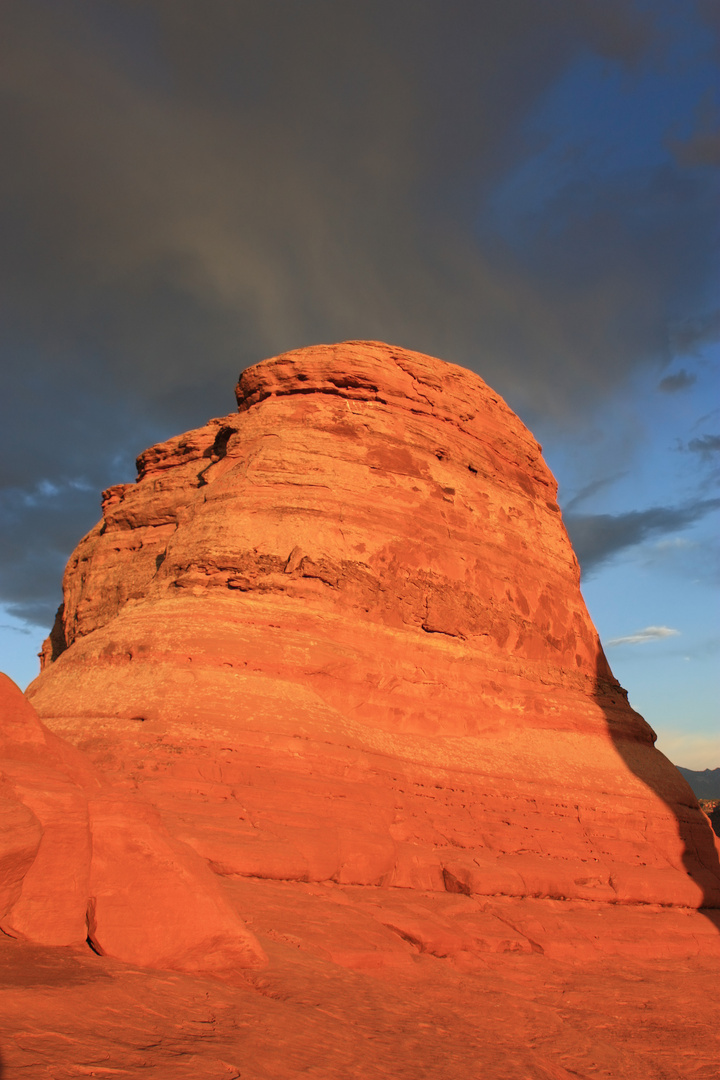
0, 0, 720, 768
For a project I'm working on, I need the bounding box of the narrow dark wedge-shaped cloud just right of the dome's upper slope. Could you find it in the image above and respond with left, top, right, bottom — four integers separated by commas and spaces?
565, 499, 720, 575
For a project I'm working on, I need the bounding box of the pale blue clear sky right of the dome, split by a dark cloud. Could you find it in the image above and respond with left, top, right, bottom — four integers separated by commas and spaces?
545, 349, 720, 769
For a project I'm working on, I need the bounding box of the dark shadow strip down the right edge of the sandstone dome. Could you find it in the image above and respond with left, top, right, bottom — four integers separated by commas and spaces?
595, 649, 720, 933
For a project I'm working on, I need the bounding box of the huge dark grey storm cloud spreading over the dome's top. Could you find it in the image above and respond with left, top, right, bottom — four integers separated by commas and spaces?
0, 0, 711, 621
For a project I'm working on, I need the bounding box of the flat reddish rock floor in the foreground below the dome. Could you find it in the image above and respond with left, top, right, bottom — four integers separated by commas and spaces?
0, 878, 720, 1080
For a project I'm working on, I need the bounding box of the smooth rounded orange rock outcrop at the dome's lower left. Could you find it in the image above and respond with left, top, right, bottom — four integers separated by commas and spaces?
0, 674, 264, 971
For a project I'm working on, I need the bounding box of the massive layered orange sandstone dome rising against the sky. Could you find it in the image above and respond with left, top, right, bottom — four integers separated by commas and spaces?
28, 341, 720, 906
